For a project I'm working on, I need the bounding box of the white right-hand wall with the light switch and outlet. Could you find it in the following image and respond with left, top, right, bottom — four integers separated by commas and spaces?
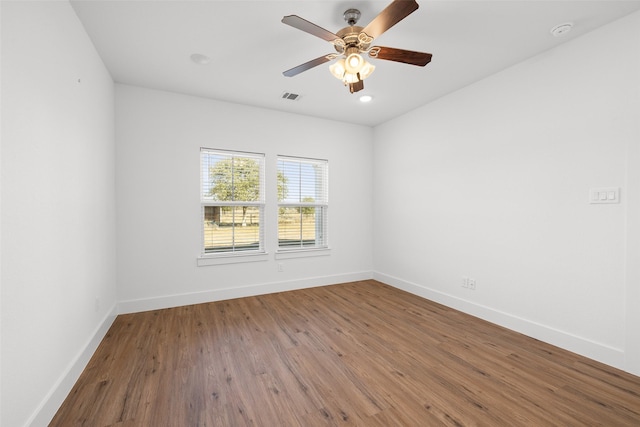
374, 8, 640, 373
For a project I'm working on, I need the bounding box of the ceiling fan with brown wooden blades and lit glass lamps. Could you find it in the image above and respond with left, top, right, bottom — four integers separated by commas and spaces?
282, 0, 431, 93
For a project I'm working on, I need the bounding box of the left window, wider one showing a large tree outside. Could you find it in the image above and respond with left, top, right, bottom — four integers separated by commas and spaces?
200, 148, 264, 255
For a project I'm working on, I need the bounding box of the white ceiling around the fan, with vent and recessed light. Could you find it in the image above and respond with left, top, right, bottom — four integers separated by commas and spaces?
71, 0, 640, 126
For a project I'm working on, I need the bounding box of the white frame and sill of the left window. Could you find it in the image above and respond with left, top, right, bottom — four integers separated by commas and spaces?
198, 147, 267, 266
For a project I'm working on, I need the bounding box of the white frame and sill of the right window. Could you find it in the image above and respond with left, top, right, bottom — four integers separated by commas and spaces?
276, 155, 330, 259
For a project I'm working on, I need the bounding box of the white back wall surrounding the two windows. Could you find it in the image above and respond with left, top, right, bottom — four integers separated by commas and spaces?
116, 85, 372, 312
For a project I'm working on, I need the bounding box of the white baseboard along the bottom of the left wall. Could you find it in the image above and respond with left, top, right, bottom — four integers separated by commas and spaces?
26, 304, 117, 427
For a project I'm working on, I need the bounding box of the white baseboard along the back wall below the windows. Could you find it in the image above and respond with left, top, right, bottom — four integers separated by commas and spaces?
118, 271, 373, 314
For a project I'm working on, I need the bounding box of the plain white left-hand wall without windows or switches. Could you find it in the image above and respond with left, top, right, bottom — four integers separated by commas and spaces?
0, 1, 116, 427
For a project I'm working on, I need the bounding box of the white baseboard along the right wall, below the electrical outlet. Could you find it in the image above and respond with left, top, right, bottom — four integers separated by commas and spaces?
373, 271, 625, 370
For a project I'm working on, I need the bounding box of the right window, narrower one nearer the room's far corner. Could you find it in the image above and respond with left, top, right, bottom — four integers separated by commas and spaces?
278, 156, 328, 250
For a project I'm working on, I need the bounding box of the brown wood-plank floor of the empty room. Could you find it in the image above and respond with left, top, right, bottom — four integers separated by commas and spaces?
51, 281, 640, 427
